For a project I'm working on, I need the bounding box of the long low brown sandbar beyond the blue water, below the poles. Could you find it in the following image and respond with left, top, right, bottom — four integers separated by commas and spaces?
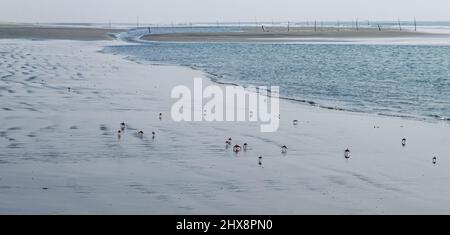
142, 28, 444, 42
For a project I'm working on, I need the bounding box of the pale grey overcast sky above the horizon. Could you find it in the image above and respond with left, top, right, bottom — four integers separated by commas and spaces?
0, 0, 450, 23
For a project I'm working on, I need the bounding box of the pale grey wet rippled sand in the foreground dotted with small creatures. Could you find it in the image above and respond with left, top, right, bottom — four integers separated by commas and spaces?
0, 29, 450, 214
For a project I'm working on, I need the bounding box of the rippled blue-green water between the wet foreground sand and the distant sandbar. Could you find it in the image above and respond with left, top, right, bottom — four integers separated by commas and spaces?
104, 27, 450, 120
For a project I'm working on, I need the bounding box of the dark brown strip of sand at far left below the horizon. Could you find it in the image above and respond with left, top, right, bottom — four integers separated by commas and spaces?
0, 24, 120, 41
